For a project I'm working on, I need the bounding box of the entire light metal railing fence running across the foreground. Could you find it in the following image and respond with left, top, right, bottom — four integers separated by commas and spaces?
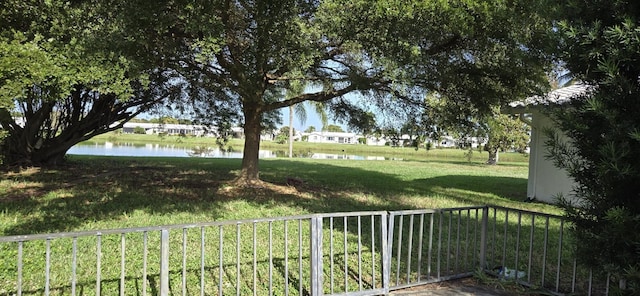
0, 207, 608, 295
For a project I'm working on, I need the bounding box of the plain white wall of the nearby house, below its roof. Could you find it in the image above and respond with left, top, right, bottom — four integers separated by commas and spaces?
527, 111, 575, 203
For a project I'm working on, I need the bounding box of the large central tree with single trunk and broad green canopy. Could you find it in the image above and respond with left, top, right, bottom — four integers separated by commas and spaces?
164, 0, 550, 183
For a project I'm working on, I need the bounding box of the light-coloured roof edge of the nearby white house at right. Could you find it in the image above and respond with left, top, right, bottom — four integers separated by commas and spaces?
507, 83, 593, 111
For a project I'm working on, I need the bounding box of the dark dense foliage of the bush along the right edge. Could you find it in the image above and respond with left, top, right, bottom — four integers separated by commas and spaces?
548, 1, 640, 295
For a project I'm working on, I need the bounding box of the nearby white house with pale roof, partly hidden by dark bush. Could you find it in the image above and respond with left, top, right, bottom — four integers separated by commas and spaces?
508, 84, 589, 203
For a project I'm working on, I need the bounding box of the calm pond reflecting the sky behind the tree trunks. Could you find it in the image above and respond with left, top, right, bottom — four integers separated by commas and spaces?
67, 142, 385, 160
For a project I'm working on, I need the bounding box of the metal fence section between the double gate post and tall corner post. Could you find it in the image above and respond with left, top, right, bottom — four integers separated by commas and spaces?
389, 207, 483, 290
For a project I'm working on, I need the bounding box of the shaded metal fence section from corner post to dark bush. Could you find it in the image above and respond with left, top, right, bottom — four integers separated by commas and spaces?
483, 207, 610, 295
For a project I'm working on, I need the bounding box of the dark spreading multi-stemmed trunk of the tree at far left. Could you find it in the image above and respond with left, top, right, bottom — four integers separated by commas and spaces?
0, 86, 158, 166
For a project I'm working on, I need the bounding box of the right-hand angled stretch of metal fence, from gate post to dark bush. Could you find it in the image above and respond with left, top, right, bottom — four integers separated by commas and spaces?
389, 206, 609, 295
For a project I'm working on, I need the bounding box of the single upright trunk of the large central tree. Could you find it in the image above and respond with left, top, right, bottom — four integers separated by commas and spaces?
236, 108, 262, 185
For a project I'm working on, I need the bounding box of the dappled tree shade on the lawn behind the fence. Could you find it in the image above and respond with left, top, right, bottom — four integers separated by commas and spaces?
0, 157, 526, 235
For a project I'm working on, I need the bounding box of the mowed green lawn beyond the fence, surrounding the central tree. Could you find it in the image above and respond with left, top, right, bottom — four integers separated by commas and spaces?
0, 150, 559, 235
